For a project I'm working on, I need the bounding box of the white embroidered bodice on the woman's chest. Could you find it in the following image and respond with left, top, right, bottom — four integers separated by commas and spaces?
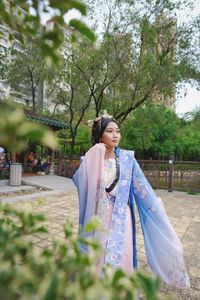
104, 158, 117, 196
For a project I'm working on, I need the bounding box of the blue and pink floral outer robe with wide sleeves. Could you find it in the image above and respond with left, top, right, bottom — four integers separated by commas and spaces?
73, 143, 190, 288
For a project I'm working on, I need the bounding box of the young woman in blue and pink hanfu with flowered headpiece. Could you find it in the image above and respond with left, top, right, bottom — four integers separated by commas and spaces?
73, 114, 190, 288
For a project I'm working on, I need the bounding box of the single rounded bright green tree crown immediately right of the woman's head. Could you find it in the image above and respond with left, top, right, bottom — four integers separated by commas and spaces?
119, 105, 180, 159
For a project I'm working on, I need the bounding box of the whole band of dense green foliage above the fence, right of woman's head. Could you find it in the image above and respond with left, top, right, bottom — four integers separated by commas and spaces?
121, 105, 200, 160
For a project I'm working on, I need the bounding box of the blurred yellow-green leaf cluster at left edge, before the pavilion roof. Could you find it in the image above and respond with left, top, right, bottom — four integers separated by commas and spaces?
0, 102, 57, 152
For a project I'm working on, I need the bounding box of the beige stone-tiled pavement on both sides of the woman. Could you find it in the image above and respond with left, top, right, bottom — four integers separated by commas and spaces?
0, 176, 200, 300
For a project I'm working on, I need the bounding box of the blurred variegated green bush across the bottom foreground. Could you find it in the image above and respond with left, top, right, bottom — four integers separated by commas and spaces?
0, 204, 172, 300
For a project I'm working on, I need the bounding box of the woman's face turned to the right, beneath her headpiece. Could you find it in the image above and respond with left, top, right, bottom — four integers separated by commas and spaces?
101, 122, 121, 147
